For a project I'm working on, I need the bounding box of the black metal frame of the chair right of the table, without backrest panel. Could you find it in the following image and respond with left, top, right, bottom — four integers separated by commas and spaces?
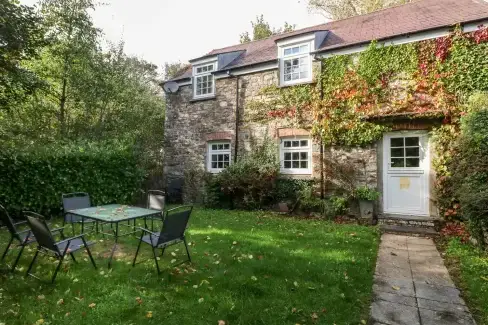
132, 206, 193, 274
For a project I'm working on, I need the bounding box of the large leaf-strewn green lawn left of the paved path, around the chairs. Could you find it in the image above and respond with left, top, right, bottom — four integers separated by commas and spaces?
0, 209, 379, 325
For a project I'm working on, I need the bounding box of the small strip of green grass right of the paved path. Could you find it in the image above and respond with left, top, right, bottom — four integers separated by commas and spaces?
446, 239, 488, 325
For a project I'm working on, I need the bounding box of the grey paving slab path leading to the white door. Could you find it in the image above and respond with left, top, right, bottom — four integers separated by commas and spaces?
371, 234, 476, 325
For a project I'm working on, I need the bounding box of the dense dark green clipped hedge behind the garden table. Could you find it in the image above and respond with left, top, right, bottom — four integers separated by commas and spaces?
0, 143, 145, 217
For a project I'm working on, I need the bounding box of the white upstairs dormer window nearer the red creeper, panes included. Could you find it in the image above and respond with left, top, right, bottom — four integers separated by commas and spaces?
280, 43, 312, 85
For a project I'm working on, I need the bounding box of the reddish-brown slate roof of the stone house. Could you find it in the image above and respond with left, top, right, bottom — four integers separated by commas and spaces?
173, 0, 488, 80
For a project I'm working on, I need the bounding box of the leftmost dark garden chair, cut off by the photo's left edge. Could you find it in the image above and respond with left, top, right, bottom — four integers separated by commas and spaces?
0, 205, 64, 271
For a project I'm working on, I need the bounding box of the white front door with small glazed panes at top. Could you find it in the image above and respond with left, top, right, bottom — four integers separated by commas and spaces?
383, 132, 430, 216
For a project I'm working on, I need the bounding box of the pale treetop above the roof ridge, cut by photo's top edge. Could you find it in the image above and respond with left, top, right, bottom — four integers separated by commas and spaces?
308, 0, 412, 20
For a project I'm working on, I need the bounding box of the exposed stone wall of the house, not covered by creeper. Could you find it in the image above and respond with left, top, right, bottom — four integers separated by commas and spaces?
164, 68, 377, 206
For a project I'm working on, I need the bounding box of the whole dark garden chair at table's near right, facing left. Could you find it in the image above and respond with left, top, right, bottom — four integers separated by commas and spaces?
132, 206, 193, 274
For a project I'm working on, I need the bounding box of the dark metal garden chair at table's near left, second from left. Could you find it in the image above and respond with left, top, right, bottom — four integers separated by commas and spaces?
24, 211, 97, 283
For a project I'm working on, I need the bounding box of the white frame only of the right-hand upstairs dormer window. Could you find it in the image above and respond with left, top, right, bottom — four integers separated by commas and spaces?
278, 40, 314, 86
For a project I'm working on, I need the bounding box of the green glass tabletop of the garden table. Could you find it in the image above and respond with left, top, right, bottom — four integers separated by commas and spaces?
69, 204, 161, 222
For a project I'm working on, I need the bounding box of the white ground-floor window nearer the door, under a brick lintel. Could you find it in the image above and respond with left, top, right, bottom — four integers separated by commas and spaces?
280, 137, 312, 174
